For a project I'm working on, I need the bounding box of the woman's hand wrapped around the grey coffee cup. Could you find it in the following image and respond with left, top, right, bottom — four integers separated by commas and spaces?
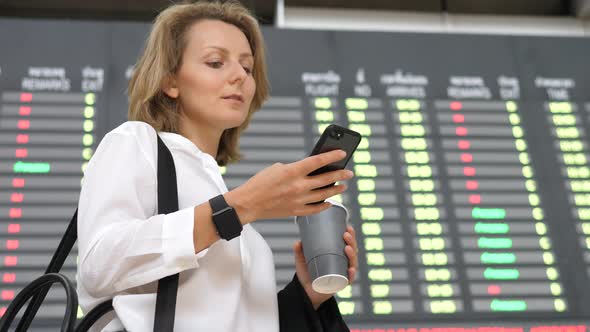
293, 226, 358, 310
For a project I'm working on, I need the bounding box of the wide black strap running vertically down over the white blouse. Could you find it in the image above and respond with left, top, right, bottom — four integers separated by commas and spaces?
154, 136, 178, 332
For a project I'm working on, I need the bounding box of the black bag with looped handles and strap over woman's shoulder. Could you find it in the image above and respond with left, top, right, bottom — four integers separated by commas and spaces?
0, 136, 178, 332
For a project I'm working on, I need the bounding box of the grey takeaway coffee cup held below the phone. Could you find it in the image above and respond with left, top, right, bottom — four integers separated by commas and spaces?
295, 200, 348, 294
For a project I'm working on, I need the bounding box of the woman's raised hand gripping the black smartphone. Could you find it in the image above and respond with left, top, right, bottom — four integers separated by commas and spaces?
224, 150, 353, 225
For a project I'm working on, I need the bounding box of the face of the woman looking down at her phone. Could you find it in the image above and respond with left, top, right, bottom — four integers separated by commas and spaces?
165, 20, 256, 131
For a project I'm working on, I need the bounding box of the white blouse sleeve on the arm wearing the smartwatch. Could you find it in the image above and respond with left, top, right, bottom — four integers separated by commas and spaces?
78, 132, 207, 297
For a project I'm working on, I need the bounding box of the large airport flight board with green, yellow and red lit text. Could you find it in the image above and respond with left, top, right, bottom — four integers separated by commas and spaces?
0, 19, 590, 332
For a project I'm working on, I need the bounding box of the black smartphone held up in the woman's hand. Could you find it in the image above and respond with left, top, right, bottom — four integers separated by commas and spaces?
309, 124, 361, 197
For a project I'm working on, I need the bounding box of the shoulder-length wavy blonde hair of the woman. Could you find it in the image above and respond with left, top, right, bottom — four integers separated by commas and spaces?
128, 0, 269, 166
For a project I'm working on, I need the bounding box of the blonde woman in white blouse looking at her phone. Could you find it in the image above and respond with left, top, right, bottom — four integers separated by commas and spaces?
77, 1, 357, 332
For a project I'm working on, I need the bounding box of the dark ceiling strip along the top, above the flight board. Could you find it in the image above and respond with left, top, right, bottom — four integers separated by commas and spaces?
0, 0, 590, 24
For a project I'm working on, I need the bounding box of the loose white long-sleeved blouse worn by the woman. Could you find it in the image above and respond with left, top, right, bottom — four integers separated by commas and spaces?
76, 121, 279, 332
